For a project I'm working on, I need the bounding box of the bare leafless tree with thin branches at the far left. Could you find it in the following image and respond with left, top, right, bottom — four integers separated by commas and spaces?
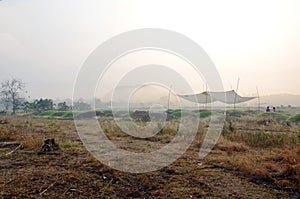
0, 78, 25, 114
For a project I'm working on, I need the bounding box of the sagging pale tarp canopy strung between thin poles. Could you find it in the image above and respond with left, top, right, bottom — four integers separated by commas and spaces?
178, 90, 256, 104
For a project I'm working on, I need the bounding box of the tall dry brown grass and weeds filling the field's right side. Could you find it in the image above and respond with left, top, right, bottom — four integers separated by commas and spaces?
206, 118, 300, 193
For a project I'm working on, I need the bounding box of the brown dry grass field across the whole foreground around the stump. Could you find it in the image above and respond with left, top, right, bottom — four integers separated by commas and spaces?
0, 109, 300, 198
